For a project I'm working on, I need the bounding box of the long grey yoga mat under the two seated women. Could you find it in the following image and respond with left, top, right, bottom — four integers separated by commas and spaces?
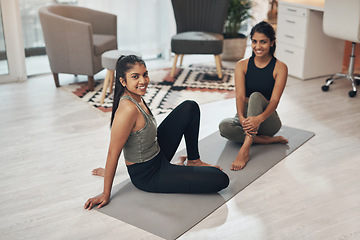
99, 126, 314, 239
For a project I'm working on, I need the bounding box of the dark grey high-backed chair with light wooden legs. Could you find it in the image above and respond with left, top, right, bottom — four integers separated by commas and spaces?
170, 0, 229, 79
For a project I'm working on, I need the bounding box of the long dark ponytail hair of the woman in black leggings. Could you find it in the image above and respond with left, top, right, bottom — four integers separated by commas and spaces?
110, 55, 146, 126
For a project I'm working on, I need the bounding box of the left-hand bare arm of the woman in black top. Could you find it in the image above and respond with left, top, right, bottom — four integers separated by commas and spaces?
235, 59, 249, 124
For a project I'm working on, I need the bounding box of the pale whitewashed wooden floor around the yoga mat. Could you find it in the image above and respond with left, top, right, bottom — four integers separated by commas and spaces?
0, 54, 360, 240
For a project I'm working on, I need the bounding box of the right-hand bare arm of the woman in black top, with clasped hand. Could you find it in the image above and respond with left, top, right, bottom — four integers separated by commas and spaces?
245, 60, 288, 129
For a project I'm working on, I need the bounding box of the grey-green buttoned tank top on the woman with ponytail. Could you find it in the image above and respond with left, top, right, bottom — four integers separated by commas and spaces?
120, 95, 160, 163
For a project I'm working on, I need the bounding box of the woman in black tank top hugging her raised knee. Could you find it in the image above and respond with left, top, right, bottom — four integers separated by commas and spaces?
219, 21, 288, 171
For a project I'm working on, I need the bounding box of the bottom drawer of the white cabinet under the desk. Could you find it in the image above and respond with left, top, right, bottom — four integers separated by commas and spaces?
276, 42, 305, 79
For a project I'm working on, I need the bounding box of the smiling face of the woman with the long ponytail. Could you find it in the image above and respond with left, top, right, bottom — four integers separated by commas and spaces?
120, 63, 150, 101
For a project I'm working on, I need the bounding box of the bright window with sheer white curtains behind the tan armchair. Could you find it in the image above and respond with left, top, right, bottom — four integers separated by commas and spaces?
18, 0, 176, 76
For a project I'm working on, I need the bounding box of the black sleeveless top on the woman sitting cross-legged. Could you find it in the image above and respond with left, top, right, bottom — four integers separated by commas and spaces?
245, 57, 276, 100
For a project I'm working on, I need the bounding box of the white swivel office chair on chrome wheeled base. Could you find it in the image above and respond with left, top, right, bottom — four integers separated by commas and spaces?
322, 0, 360, 97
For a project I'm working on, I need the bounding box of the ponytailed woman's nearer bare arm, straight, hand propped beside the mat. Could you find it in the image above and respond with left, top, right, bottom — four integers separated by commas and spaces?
84, 101, 139, 210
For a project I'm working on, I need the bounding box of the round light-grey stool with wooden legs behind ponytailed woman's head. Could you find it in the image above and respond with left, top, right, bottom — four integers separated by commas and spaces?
100, 50, 141, 104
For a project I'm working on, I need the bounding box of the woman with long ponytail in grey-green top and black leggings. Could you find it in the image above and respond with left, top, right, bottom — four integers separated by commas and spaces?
84, 55, 229, 210
